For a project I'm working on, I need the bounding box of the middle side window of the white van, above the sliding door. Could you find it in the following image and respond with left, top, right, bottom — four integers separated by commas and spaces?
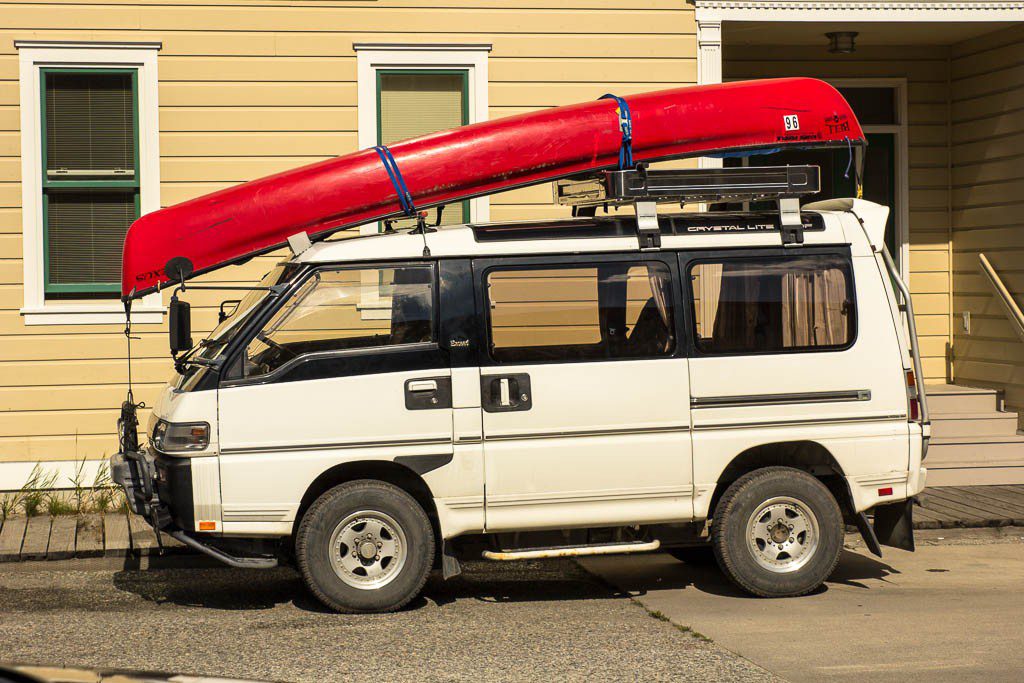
485, 261, 676, 362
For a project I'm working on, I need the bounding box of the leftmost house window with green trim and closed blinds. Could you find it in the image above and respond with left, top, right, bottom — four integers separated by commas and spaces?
40, 69, 139, 299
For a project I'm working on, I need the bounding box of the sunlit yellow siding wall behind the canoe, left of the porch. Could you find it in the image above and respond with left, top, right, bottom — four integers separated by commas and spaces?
0, 0, 696, 462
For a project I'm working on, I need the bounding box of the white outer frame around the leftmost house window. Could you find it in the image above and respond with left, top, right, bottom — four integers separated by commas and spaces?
14, 41, 164, 325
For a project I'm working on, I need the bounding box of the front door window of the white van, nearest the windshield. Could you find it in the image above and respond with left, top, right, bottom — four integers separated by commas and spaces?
245, 265, 434, 377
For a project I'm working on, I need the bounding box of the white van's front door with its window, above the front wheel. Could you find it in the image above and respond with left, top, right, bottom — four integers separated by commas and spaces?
218, 264, 453, 532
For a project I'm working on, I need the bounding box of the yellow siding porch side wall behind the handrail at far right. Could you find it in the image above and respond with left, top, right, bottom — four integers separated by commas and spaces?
951, 27, 1024, 421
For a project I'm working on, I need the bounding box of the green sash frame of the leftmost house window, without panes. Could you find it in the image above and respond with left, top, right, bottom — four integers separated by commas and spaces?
39, 67, 141, 294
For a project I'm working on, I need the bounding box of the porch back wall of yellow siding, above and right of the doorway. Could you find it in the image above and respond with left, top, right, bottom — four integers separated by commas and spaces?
723, 40, 950, 382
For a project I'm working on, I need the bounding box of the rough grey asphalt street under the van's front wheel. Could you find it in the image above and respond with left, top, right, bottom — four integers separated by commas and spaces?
0, 560, 777, 682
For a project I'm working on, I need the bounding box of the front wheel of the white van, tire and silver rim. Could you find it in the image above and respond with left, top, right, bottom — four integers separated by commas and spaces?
295, 479, 434, 612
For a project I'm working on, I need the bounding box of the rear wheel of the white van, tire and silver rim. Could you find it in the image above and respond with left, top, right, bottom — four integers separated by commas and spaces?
712, 467, 843, 598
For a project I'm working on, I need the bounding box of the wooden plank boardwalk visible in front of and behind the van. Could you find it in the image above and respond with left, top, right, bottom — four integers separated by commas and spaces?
0, 485, 1024, 562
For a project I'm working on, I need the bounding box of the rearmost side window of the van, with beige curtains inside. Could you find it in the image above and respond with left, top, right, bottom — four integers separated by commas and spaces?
689, 255, 856, 353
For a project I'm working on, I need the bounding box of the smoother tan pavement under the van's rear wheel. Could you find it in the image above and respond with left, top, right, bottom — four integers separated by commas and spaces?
582, 527, 1024, 683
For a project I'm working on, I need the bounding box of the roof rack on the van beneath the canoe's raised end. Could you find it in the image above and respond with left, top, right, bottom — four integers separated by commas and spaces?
554, 165, 821, 249
